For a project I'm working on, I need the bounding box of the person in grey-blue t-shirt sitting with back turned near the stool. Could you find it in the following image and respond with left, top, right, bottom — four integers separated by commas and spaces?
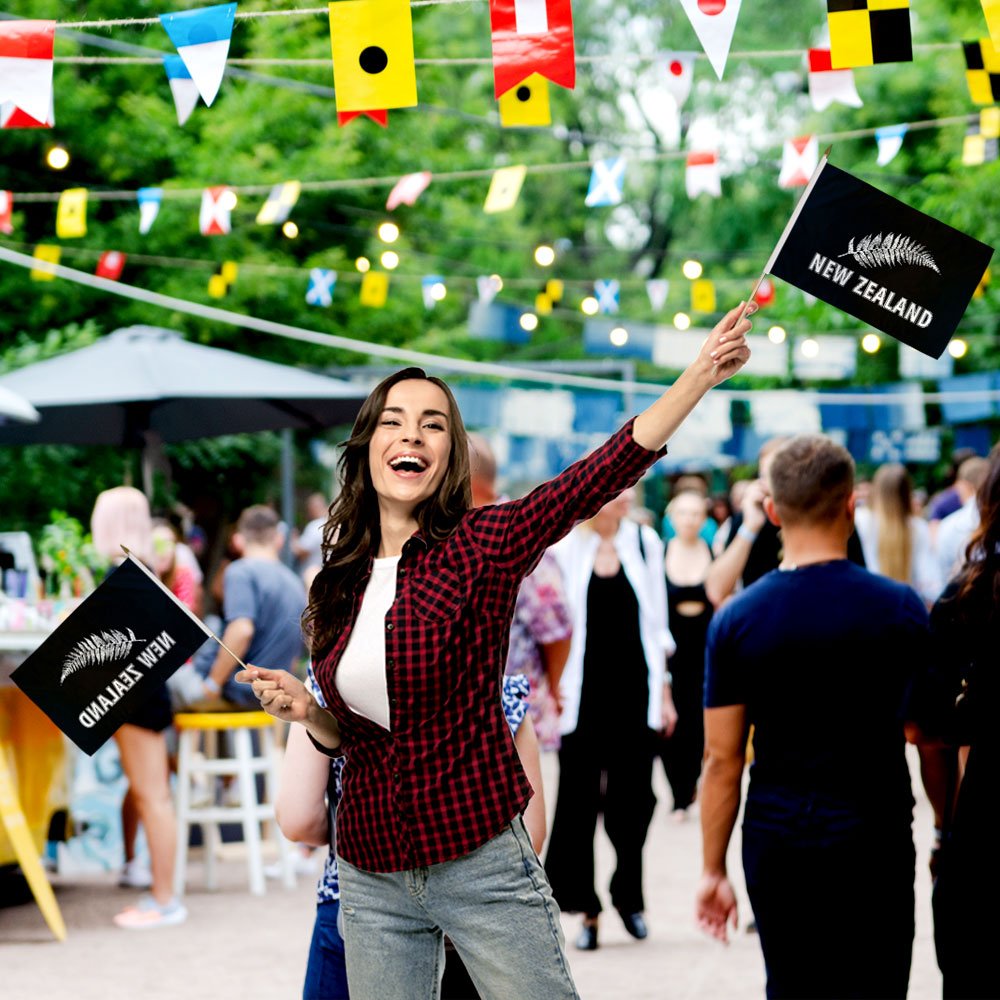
205, 505, 306, 708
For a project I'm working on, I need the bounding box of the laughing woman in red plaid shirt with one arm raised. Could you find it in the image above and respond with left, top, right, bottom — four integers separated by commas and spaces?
238, 309, 750, 1000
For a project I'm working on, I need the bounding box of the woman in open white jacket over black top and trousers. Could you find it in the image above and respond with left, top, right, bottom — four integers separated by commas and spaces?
545, 490, 677, 950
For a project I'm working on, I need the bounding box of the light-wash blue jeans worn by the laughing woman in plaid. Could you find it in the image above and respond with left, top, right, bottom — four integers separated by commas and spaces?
337, 817, 579, 1000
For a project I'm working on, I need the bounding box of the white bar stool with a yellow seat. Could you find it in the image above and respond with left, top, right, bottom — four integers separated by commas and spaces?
174, 712, 295, 896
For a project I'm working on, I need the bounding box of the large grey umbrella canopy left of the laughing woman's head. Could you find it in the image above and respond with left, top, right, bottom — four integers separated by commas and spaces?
0, 326, 367, 447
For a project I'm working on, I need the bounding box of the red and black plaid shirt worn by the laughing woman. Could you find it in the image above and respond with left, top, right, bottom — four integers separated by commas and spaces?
316, 423, 662, 872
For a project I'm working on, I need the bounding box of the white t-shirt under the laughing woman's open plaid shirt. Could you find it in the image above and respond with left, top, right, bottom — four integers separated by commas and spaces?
336, 556, 399, 729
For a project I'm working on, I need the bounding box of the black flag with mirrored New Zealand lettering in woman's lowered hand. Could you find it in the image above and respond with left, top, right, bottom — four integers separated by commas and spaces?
11, 556, 214, 754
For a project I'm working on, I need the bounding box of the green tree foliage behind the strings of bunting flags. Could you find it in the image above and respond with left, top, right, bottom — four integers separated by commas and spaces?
0, 0, 1000, 521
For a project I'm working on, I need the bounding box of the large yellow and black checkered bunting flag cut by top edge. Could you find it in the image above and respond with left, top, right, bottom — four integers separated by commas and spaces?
826, 0, 913, 69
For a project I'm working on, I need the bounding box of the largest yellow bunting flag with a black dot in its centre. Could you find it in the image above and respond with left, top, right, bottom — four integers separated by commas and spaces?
330, 0, 417, 112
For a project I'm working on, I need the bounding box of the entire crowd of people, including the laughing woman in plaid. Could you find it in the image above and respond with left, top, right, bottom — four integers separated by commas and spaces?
68, 309, 1000, 1000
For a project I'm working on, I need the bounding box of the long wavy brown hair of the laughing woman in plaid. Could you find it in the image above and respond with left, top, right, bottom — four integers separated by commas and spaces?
302, 368, 472, 660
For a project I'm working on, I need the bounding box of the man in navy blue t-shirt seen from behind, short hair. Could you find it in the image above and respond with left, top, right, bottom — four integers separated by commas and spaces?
697, 436, 928, 997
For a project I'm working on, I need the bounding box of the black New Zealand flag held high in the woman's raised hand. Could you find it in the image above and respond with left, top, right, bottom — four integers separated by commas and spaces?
765, 155, 993, 358
